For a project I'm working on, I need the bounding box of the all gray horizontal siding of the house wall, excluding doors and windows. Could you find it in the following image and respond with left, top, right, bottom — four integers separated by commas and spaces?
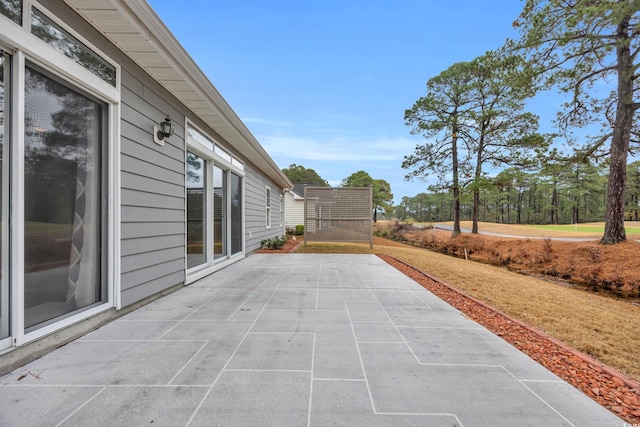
40, 0, 284, 306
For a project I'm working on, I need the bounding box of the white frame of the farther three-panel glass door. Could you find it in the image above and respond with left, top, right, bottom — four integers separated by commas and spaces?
184, 118, 246, 285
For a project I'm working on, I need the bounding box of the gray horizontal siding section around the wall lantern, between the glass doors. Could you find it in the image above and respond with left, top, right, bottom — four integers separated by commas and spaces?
120, 70, 186, 306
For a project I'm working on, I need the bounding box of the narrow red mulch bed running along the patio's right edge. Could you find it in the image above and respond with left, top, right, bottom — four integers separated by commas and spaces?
378, 255, 640, 425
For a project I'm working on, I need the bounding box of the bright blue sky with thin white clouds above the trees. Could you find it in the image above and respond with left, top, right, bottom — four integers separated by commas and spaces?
148, 0, 540, 203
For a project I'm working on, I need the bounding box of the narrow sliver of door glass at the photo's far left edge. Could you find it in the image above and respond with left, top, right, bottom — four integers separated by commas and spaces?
0, 50, 11, 339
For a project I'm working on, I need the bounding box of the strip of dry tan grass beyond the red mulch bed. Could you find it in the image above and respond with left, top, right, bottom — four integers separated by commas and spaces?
297, 237, 640, 380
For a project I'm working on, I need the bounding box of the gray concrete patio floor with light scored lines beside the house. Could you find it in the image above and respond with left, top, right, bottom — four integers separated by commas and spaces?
0, 254, 623, 427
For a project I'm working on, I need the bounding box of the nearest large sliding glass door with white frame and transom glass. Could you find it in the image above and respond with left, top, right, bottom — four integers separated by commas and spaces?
0, 0, 121, 352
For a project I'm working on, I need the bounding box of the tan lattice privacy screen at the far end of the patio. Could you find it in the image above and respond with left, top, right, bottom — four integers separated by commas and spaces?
304, 186, 373, 247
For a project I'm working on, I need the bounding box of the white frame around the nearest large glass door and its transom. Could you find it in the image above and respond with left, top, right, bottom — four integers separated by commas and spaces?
0, 0, 122, 352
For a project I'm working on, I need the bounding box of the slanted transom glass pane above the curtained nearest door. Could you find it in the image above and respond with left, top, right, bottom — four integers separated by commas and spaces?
31, 7, 116, 86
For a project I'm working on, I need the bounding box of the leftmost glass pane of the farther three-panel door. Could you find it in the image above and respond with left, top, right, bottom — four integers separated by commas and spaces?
187, 152, 207, 268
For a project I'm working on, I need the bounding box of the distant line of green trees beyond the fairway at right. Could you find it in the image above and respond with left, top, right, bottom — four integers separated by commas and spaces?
393, 161, 640, 224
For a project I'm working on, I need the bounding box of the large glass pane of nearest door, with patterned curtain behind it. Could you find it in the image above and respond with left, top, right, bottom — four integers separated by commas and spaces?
24, 67, 107, 328
